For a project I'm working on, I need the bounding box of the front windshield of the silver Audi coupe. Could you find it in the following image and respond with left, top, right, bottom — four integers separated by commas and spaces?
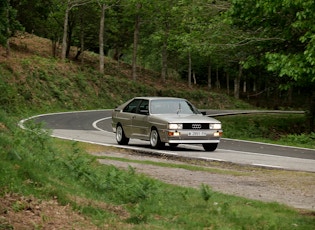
150, 99, 200, 114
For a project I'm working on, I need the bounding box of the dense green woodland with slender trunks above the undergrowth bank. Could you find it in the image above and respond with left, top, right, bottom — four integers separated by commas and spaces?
0, 0, 315, 130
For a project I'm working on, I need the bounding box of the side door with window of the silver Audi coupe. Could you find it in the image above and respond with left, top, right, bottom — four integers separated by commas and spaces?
132, 99, 150, 140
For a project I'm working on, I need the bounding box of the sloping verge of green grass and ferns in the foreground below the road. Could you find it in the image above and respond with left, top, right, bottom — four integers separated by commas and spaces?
0, 112, 315, 229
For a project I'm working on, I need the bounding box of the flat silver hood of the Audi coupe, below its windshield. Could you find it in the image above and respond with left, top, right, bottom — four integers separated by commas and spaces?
150, 114, 221, 123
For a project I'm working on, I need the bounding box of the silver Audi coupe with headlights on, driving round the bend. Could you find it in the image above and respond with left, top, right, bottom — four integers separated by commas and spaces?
112, 97, 223, 151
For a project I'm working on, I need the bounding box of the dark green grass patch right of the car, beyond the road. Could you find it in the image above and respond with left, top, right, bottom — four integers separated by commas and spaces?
218, 114, 315, 149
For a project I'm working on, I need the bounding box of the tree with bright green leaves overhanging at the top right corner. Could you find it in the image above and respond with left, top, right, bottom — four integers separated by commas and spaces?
230, 0, 315, 131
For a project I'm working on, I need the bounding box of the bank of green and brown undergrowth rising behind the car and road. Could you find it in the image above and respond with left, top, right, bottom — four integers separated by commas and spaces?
0, 51, 251, 114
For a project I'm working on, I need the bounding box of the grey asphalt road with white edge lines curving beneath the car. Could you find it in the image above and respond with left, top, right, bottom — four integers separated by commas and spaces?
21, 110, 315, 172
